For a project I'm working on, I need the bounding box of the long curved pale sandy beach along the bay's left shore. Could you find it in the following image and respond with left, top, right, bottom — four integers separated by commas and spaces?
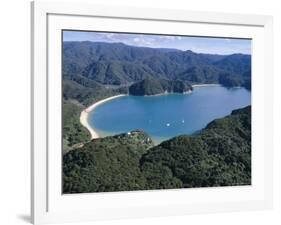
80, 95, 126, 139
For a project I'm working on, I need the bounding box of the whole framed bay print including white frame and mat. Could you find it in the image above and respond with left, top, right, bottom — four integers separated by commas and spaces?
31, 1, 273, 224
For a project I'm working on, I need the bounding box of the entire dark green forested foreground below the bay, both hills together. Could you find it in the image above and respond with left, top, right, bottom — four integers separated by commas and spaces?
63, 106, 251, 193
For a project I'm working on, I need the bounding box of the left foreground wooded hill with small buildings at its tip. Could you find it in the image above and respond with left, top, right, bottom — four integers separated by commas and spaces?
63, 131, 153, 193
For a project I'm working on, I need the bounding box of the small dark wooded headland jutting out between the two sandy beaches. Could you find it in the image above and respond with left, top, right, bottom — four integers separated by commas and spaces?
129, 78, 192, 96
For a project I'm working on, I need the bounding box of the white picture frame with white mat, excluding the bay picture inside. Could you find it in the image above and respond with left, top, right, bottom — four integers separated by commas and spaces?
31, 1, 273, 224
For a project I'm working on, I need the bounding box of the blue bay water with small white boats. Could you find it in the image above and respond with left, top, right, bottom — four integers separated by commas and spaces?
89, 86, 251, 143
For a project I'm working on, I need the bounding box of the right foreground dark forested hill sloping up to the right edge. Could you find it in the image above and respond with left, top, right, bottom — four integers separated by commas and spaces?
141, 107, 251, 189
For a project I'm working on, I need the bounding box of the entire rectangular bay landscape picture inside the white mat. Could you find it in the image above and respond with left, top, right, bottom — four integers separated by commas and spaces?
60, 30, 252, 194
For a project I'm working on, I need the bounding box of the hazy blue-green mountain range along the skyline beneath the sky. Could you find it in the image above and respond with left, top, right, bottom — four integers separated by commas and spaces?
63, 41, 251, 89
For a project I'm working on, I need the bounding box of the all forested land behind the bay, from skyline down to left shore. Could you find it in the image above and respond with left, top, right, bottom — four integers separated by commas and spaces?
62, 41, 251, 149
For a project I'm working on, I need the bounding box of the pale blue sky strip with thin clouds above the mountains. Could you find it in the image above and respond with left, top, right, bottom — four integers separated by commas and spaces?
63, 31, 251, 55
